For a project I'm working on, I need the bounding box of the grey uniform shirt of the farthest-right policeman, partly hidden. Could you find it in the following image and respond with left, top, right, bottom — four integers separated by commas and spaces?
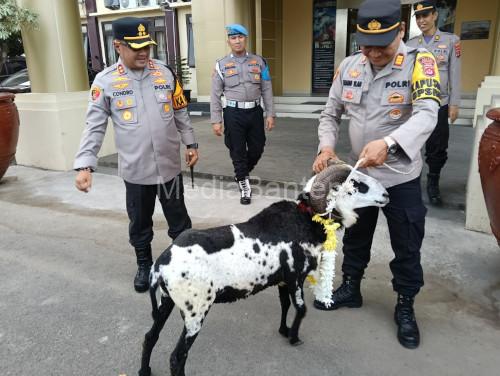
407, 30, 462, 106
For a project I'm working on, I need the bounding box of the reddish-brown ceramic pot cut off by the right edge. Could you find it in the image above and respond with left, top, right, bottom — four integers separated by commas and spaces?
478, 108, 500, 245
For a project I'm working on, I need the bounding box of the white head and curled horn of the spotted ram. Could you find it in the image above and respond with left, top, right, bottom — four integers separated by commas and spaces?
304, 160, 389, 227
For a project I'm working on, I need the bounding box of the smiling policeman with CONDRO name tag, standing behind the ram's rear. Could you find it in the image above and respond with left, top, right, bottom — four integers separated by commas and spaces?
74, 17, 198, 292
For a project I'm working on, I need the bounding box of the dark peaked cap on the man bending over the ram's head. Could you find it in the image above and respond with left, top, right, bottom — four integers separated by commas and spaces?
356, 0, 401, 46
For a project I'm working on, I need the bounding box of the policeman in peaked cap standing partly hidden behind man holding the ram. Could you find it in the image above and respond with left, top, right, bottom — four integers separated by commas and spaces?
408, 0, 461, 206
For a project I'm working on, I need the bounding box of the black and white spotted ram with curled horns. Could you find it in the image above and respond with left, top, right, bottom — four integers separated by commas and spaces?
139, 162, 388, 376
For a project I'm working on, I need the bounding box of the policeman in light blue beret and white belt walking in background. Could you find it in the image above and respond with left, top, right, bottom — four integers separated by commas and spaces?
210, 24, 274, 205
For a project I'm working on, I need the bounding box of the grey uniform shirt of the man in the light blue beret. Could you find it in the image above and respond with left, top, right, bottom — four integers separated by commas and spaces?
210, 52, 274, 124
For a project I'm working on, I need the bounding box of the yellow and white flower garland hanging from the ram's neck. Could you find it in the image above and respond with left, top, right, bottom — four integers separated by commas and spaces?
307, 214, 340, 307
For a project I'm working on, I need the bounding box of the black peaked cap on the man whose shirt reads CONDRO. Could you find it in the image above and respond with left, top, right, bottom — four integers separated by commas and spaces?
112, 17, 156, 50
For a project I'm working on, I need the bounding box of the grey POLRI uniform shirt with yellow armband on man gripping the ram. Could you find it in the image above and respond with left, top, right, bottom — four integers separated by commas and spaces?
318, 42, 439, 188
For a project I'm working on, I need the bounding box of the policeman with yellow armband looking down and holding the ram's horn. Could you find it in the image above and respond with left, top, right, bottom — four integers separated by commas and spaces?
313, 0, 440, 348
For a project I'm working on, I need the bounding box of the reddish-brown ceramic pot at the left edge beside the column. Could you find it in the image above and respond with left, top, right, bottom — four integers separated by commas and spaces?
0, 93, 19, 179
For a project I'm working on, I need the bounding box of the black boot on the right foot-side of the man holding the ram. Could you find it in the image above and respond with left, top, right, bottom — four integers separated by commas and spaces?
394, 294, 420, 349
